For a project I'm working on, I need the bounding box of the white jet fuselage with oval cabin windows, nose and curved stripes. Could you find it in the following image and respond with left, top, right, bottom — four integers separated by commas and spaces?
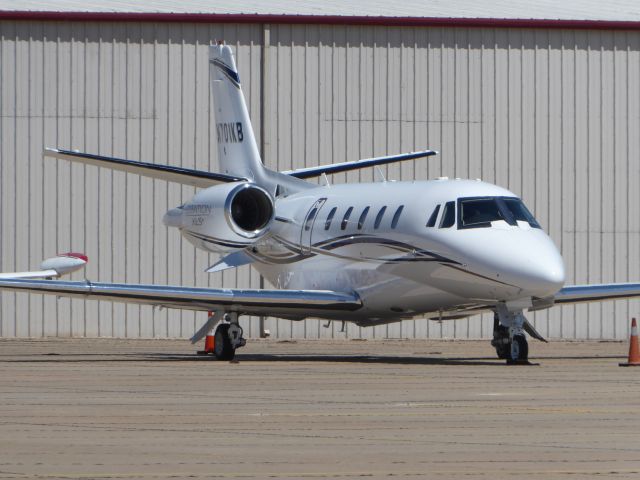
175, 179, 564, 325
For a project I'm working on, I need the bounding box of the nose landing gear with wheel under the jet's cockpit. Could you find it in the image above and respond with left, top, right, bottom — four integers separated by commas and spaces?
491, 304, 546, 365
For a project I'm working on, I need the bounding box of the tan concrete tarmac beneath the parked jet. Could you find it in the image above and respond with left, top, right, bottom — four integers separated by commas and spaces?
0, 339, 640, 479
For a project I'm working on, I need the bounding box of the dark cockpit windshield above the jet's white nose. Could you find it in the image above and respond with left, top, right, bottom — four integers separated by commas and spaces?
458, 197, 540, 229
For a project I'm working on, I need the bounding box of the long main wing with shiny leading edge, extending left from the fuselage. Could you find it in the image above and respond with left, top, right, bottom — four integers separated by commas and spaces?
0, 278, 362, 318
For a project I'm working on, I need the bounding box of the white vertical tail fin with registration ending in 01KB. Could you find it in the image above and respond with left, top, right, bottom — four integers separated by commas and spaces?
209, 43, 264, 180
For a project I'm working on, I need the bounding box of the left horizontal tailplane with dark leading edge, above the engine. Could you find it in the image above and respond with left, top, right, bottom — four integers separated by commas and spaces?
44, 148, 246, 188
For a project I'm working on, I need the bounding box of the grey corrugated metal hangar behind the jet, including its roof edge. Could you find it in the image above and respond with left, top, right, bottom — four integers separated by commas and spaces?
0, 0, 640, 339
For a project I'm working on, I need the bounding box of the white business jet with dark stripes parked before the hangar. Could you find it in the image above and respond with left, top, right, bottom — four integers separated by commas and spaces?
0, 43, 640, 363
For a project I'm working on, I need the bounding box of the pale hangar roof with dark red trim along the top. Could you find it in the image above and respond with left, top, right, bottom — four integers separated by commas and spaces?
0, 0, 640, 29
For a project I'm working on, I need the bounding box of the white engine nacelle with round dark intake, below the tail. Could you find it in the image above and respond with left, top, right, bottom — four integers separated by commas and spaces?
163, 182, 275, 253
